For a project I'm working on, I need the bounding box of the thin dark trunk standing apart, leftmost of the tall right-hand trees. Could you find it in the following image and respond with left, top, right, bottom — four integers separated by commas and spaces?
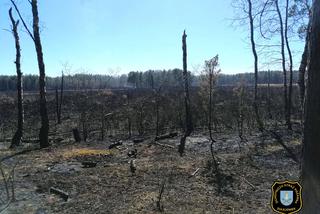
247, 0, 264, 132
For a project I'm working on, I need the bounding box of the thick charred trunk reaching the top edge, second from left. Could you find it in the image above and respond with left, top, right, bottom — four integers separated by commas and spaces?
31, 0, 50, 148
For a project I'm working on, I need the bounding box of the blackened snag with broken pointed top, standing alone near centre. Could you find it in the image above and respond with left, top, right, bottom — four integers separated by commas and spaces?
178, 31, 193, 156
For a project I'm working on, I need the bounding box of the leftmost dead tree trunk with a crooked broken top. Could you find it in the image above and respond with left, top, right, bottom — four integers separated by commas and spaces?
9, 8, 24, 148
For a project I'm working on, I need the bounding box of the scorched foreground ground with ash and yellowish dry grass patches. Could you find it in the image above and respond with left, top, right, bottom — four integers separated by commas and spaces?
0, 127, 301, 214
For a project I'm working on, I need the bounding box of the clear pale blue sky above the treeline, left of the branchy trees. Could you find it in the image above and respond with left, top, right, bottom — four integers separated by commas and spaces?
0, 0, 302, 76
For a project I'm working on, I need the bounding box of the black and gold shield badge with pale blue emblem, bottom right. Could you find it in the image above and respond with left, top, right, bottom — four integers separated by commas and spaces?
271, 181, 302, 214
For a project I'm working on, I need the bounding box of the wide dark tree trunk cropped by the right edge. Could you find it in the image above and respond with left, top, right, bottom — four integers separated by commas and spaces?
302, 0, 320, 213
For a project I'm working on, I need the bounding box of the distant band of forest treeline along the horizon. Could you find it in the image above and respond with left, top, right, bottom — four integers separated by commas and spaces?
0, 69, 298, 91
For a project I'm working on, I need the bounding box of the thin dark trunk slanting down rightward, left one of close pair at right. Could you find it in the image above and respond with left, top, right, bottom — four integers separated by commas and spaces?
275, 0, 291, 129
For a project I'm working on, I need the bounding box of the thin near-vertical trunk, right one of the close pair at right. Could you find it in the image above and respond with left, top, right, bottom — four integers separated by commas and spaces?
284, 0, 293, 130
